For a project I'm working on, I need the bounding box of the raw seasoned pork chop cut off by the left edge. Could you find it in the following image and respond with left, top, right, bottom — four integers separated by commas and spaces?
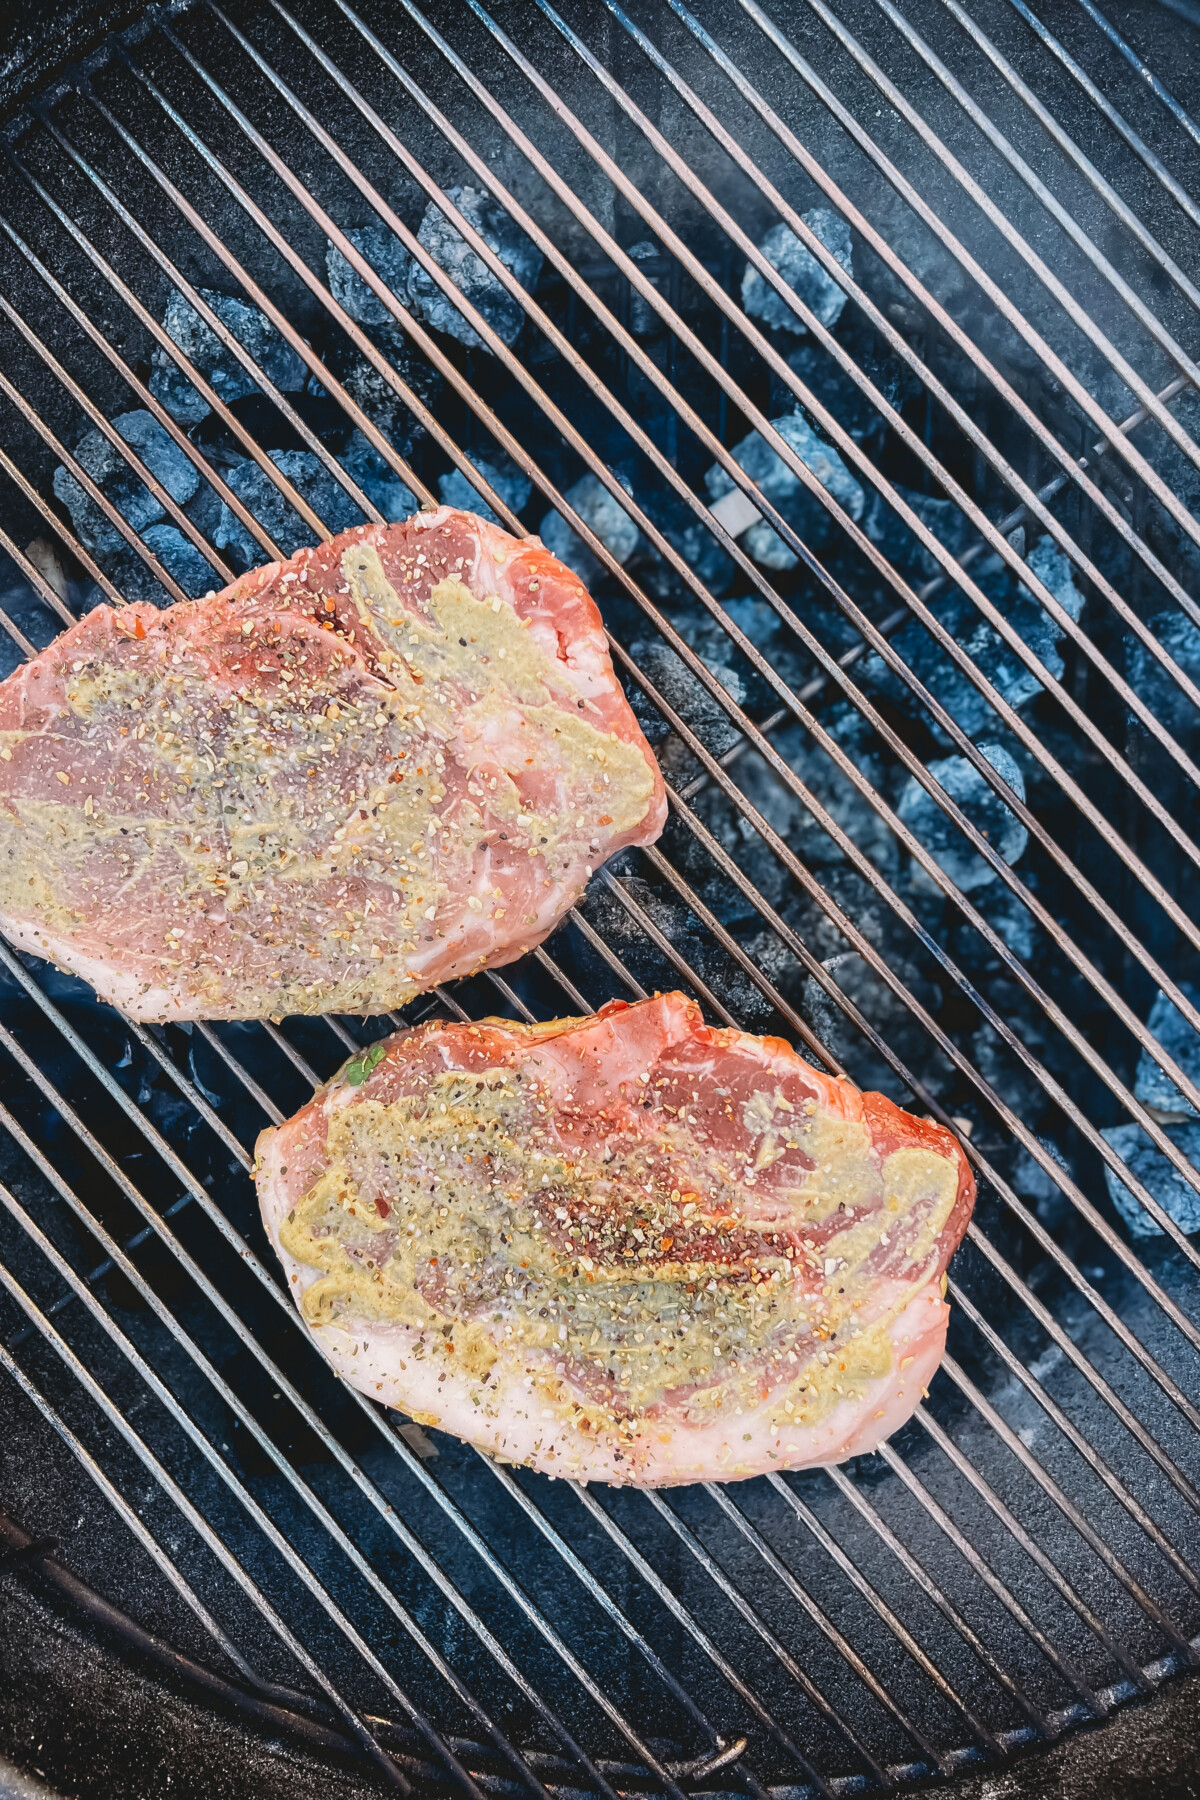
0, 508, 666, 1019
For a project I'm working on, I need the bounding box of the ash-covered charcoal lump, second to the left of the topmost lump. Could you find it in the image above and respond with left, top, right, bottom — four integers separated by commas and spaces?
149, 288, 308, 425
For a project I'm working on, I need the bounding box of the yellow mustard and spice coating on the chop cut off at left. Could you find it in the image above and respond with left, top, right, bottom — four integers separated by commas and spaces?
0, 542, 655, 1015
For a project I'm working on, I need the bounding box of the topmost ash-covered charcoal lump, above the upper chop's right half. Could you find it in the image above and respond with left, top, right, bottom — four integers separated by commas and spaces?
408, 187, 542, 349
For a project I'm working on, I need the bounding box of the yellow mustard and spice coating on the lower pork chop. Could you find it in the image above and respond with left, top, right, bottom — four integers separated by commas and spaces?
279, 1067, 957, 1431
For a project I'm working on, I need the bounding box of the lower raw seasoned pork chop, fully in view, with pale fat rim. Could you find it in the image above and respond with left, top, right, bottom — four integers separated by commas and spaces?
257, 994, 975, 1485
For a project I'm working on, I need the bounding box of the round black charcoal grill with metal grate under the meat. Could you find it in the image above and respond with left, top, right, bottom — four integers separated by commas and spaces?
0, 0, 1200, 1800
